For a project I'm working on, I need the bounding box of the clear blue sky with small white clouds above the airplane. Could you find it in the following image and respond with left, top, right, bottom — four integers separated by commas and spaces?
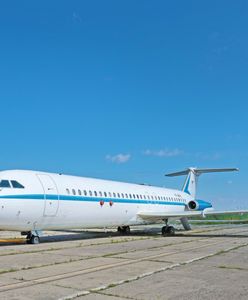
0, 0, 248, 208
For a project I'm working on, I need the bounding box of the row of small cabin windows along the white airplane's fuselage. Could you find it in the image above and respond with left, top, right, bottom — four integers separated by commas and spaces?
66, 188, 185, 202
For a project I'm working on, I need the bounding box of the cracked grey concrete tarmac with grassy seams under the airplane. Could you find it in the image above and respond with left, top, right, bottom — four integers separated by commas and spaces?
0, 225, 248, 300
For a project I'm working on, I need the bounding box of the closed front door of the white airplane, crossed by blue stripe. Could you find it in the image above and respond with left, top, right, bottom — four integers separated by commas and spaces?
37, 174, 59, 217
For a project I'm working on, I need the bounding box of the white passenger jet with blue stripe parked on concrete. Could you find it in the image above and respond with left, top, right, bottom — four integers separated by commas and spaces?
0, 168, 245, 244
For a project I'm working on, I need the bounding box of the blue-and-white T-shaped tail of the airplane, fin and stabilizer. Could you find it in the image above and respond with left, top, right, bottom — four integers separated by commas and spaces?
166, 168, 239, 198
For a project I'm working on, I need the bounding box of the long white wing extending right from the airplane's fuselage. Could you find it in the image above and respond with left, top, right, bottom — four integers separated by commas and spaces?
138, 210, 248, 220
